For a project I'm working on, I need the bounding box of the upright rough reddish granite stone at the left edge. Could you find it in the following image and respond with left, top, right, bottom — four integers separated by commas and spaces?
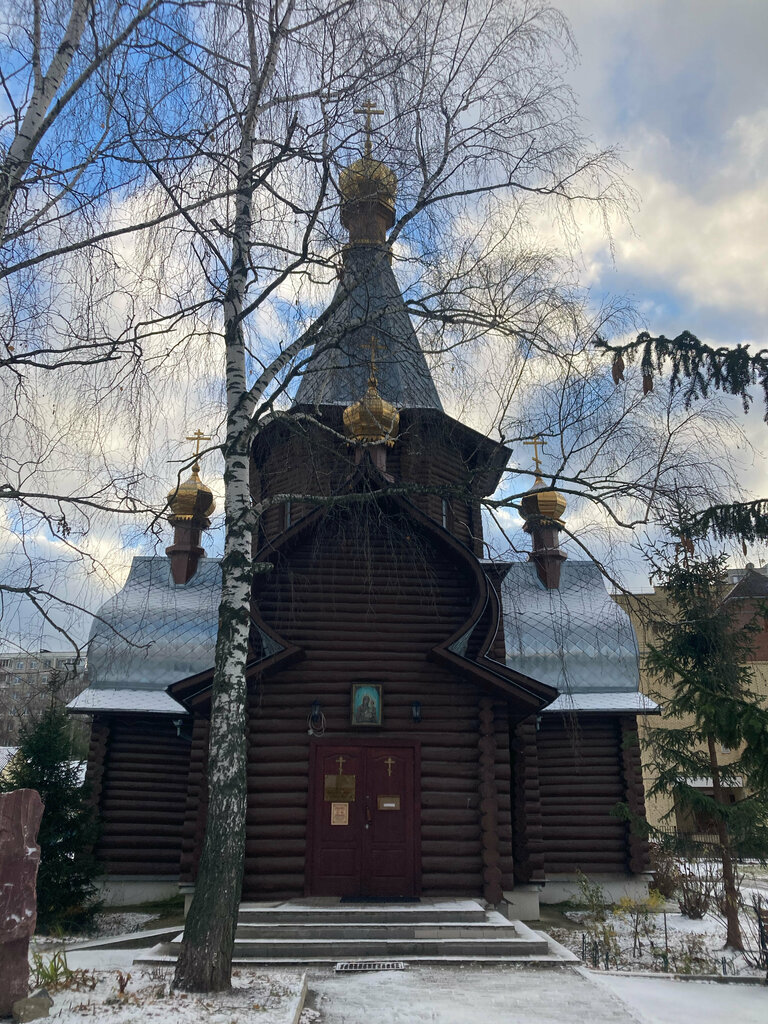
0, 790, 43, 1016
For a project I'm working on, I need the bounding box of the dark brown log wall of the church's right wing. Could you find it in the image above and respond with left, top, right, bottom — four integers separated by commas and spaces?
537, 714, 630, 874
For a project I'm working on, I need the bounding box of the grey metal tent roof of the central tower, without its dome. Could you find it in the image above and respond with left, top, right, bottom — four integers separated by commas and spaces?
294, 245, 442, 411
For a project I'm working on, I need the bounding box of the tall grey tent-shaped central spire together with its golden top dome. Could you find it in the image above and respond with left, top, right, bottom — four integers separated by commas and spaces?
294, 141, 442, 412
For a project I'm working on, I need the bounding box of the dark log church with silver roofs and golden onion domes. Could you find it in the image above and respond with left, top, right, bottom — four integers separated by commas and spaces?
70, 138, 652, 915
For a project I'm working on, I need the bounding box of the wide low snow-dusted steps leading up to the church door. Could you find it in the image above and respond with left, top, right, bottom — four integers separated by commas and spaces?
136, 899, 570, 965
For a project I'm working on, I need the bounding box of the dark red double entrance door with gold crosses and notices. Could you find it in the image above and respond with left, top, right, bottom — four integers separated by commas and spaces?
306, 739, 420, 898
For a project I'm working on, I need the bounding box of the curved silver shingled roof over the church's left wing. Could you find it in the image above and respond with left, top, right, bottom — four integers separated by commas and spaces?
86, 555, 221, 692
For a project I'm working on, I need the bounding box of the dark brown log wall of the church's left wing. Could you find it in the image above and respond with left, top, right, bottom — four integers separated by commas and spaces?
94, 716, 189, 877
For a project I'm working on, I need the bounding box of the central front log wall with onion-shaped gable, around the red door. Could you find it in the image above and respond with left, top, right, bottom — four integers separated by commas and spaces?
244, 509, 505, 899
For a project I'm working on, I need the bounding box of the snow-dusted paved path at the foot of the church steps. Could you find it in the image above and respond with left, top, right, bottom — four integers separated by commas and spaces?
303, 967, 768, 1024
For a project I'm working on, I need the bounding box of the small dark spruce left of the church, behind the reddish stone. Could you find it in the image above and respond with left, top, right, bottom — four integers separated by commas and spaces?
0, 699, 98, 932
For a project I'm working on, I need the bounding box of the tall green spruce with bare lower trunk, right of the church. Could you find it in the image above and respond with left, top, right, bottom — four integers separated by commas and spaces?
646, 542, 768, 949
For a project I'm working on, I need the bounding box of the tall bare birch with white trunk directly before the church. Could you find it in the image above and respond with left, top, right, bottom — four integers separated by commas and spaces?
4, 0, 745, 990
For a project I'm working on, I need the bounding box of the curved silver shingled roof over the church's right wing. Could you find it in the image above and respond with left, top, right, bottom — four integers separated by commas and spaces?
502, 560, 640, 695
